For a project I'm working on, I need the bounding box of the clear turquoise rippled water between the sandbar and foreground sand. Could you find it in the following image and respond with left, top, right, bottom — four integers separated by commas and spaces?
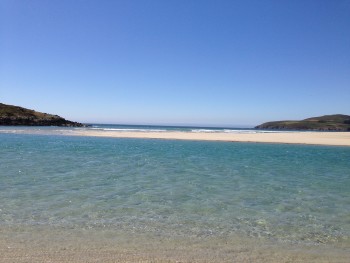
0, 133, 350, 248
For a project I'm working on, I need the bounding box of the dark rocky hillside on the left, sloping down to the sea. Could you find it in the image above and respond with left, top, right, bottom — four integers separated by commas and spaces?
0, 103, 84, 127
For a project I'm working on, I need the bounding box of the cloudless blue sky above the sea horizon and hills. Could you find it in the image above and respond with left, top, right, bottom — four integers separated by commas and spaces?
0, 0, 350, 126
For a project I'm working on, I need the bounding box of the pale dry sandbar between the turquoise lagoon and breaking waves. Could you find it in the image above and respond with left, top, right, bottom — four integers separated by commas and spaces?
73, 130, 350, 146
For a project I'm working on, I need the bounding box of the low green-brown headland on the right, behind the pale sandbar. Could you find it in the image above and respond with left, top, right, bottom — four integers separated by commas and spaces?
255, 114, 350, 131
